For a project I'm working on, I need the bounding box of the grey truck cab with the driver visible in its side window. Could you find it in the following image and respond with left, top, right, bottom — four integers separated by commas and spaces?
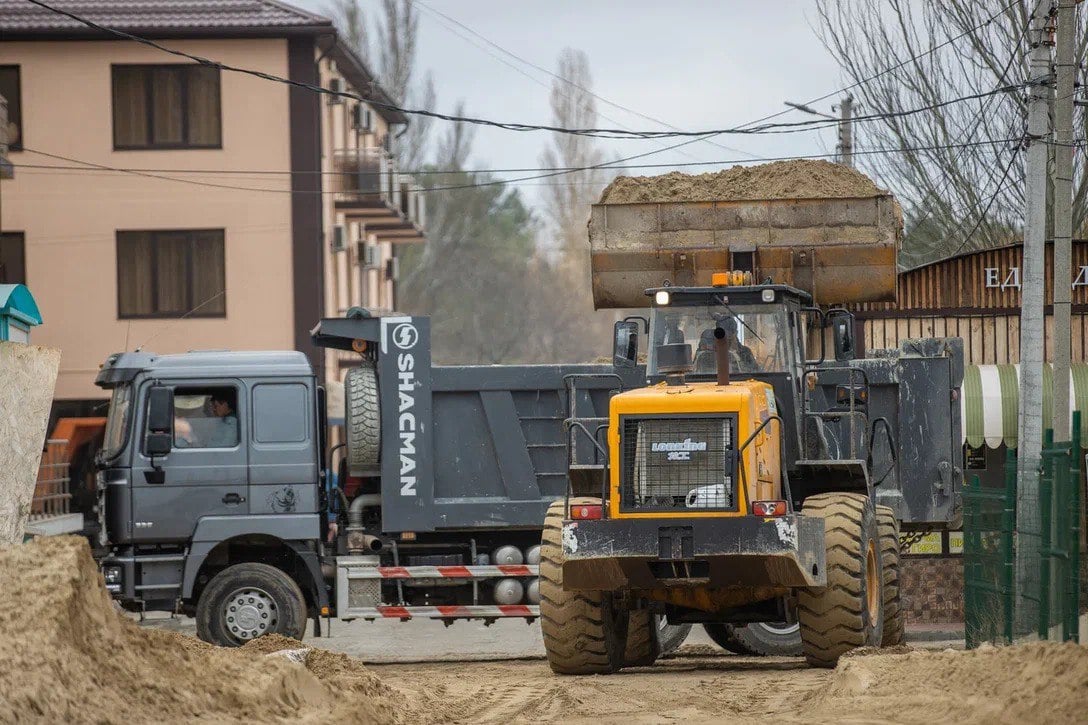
97, 352, 327, 642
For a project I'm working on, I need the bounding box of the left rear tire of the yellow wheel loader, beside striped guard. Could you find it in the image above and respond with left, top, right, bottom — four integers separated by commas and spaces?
540, 499, 626, 675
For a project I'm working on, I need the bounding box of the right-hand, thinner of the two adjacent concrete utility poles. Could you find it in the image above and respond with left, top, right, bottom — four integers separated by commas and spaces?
1053, 0, 1088, 441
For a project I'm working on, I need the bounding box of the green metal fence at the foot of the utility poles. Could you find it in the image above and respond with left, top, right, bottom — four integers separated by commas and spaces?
963, 413, 1083, 648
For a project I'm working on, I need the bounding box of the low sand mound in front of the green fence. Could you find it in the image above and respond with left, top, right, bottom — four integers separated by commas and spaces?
804, 642, 1088, 723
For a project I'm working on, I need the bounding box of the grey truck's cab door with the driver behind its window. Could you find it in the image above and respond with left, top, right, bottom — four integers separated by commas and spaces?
132, 381, 249, 542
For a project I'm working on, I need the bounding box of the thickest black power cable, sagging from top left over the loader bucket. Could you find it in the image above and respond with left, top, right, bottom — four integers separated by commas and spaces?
27, 0, 1027, 141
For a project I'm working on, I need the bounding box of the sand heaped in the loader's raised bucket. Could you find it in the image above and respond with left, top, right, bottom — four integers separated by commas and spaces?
601, 159, 888, 204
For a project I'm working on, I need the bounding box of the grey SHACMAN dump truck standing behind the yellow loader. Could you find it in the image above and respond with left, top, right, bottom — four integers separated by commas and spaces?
96, 309, 690, 647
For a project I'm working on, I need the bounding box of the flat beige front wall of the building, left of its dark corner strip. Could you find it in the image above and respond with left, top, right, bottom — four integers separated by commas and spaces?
0, 39, 295, 400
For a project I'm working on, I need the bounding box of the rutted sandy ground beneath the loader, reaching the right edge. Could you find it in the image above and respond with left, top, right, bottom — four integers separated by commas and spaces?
369, 644, 1088, 725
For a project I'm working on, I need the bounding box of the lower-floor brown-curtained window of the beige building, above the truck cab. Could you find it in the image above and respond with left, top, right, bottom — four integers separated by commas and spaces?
118, 229, 226, 319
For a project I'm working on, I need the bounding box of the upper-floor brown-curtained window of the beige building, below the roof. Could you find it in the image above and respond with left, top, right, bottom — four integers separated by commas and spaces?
113, 63, 222, 149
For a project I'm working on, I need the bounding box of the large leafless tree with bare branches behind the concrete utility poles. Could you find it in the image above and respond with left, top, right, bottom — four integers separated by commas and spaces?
817, 0, 1088, 268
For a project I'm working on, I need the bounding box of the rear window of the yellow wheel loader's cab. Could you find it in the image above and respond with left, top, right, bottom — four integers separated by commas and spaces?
648, 305, 791, 376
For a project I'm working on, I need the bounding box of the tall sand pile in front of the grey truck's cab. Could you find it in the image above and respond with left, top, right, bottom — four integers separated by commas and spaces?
0, 538, 413, 725
